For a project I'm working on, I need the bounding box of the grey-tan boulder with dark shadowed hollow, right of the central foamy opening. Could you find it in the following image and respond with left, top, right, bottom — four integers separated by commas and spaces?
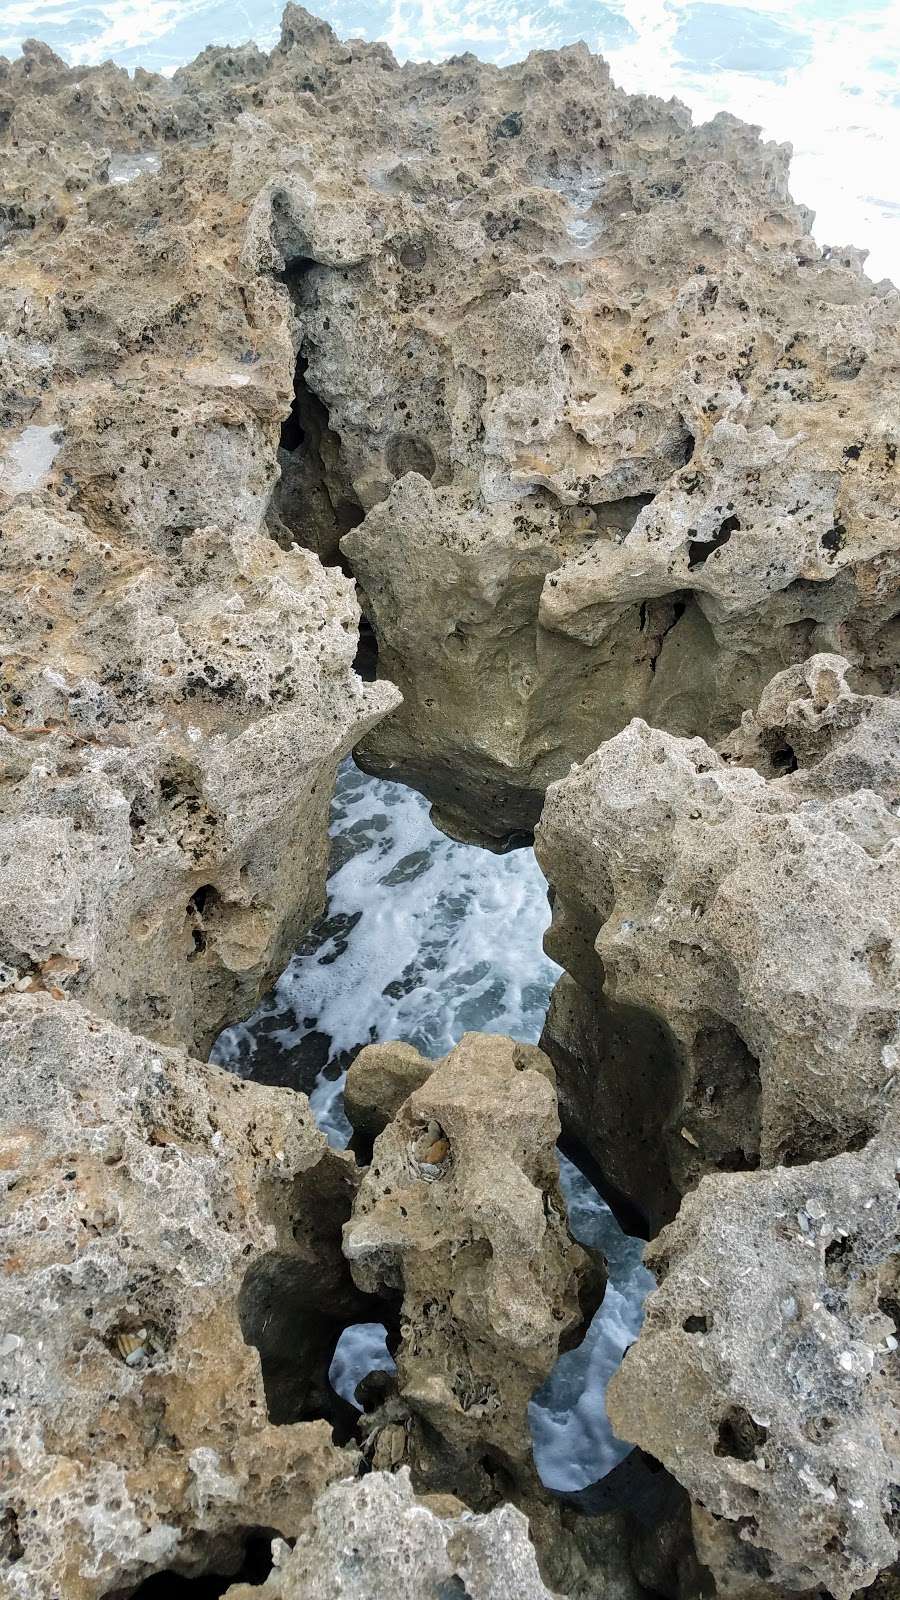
536, 656, 900, 1221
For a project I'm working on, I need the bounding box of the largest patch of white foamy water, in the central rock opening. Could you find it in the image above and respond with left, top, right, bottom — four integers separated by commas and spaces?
215, 762, 560, 1144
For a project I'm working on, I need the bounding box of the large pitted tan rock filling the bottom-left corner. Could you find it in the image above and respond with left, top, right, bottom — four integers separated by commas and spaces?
0, 995, 354, 1600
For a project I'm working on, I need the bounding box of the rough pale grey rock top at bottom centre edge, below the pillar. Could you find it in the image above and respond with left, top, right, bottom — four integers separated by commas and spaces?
226, 1467, 552, 1600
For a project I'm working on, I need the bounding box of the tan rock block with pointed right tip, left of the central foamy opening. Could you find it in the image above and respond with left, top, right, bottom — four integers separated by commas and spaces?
0, 507, 389, 1048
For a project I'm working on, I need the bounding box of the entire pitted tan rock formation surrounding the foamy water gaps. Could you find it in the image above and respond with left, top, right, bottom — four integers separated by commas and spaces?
0, 5, 900, 1600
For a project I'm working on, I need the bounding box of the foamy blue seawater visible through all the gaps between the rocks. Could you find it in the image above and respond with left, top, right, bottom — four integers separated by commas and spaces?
211, 760, 653, 1490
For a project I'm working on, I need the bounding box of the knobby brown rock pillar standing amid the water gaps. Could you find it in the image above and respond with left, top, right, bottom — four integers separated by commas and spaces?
344, 1034, 602, 1507
